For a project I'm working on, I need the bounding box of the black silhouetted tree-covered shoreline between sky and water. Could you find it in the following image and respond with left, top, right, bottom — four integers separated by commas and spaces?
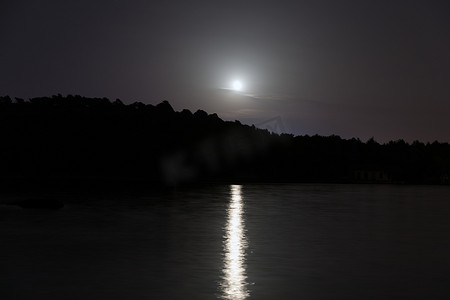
0, 95, 450, 190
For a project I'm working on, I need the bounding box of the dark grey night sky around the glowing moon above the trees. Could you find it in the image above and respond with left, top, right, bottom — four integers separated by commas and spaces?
0, 0, 450, 142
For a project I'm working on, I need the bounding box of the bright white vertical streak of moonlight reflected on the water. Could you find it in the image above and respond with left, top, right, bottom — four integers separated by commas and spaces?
220, 185, 250, 300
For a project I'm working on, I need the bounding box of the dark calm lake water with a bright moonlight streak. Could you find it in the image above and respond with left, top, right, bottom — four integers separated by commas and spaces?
0, 184, 450, 299
